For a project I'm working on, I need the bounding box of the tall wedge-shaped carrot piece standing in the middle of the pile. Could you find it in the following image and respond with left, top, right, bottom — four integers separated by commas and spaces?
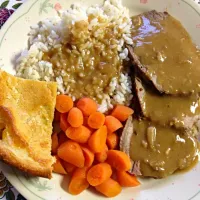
88, 126, 107, 153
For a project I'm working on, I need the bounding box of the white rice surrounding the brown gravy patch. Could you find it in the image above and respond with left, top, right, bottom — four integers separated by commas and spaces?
16, 0, 132, 112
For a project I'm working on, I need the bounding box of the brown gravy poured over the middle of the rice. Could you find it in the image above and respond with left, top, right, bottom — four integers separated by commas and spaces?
42, 21, 122, 103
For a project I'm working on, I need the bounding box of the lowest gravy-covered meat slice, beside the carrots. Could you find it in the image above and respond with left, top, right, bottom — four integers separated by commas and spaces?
120, 117, 199, 178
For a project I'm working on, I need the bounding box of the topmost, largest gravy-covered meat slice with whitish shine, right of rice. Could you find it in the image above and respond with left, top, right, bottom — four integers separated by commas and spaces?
128, 11, 200, 95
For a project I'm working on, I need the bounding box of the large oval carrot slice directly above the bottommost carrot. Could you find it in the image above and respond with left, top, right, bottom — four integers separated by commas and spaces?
87, 163, 112, 186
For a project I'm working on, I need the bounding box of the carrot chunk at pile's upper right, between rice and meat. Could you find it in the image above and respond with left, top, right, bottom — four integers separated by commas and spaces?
111, 105, 134, 122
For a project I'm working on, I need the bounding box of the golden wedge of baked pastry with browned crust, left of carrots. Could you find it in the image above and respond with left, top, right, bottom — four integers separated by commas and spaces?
0, 71, 57, 179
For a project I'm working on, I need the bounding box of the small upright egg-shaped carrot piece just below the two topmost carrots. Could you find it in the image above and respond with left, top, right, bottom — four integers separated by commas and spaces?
67, 107, 83, 127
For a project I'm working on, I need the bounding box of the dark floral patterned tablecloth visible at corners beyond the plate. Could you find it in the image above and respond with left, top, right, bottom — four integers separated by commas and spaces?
0, 0, 200, 200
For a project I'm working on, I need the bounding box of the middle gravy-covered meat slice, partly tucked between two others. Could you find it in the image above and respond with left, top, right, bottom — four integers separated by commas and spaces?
135, 78, 200, 129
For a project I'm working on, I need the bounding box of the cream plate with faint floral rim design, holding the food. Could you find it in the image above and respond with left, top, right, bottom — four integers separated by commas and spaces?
0, 0, 200, 200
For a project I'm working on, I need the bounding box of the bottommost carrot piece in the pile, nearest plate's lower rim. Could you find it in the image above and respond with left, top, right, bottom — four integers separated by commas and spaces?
95, 178, 122, 197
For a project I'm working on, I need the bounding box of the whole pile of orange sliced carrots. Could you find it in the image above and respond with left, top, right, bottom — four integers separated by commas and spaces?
52, 95, 140, 197
